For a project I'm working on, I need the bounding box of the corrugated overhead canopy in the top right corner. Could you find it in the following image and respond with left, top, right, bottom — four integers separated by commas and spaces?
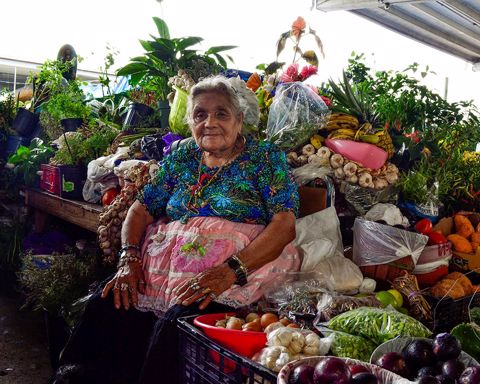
316, 0, 480, 63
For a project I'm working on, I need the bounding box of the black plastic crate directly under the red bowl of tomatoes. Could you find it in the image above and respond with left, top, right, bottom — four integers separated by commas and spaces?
177, 316, 277, 384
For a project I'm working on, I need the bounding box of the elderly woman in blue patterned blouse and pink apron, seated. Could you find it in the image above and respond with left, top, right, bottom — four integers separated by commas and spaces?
53, 76, 299, 384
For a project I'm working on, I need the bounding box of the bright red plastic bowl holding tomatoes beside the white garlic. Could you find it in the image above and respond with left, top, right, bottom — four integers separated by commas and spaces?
193, 313, 267, 357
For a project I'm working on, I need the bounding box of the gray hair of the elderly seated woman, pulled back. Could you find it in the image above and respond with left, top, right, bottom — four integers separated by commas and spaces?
185, 75, 260, 127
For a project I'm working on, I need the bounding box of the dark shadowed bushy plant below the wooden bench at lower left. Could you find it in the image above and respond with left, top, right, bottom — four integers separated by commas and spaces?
18, 250, 96, 313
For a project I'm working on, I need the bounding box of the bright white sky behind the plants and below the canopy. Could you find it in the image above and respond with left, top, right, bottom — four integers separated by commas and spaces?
0, 0, 480, 107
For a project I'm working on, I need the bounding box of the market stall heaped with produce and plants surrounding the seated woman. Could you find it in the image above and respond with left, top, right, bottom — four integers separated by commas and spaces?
0, 13, 480, 384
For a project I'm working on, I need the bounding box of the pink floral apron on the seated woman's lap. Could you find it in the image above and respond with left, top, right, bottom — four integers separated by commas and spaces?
137, 217, 300, 314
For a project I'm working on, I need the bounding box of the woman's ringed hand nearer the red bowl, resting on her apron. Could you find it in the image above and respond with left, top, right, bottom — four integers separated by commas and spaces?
173, 264, 236, 309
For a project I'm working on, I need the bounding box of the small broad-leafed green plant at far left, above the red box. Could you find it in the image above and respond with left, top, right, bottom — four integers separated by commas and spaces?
8, 138, 53, 186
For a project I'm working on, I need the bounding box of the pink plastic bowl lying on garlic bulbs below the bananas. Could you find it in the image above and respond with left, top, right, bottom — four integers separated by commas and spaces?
325, 139, 388, 169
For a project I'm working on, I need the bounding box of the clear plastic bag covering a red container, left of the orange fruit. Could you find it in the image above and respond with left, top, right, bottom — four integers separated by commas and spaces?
353, 218, 428, 266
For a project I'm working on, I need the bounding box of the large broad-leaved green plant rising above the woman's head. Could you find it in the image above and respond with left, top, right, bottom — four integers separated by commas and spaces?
117, 17, 235, 100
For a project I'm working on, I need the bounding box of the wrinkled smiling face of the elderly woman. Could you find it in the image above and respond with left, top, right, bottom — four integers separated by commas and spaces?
192, 92, 243, 153
